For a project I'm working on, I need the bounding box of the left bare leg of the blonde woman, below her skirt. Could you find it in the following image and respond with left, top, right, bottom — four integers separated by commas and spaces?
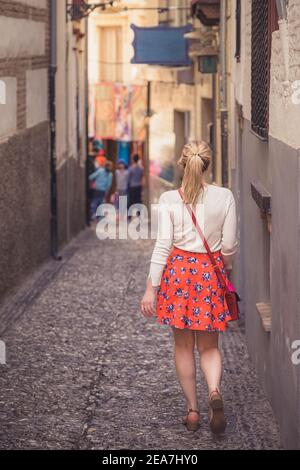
173, 328, 198, 419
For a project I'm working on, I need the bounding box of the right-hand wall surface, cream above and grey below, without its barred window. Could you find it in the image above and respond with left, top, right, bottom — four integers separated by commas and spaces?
229, 0, 300, 448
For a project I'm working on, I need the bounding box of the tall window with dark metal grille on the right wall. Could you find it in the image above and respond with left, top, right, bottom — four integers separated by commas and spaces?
251, 0, 278, 140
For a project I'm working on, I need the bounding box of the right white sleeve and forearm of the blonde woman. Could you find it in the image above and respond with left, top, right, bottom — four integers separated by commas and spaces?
221, 192, 239, 269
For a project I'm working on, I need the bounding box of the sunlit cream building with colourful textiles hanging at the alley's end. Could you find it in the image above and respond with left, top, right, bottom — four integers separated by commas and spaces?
88, 0, 157, 207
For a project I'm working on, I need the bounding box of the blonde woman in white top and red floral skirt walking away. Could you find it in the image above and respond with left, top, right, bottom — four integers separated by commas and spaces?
141, 141, 239, 433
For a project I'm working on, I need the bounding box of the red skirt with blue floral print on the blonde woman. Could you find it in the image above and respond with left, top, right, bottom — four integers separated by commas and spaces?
156, 247, 231, 331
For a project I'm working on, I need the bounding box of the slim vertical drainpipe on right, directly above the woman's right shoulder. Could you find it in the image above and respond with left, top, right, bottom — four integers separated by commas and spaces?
220, 0, 229, 186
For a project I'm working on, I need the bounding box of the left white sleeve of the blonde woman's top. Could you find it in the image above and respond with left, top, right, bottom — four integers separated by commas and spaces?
148, 194, 174, 287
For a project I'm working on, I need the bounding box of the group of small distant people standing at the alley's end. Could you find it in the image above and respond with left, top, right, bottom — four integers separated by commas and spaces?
89, 140, 144, 220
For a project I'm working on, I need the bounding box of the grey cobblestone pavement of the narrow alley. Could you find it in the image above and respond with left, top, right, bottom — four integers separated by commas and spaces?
0, 229, 280, 450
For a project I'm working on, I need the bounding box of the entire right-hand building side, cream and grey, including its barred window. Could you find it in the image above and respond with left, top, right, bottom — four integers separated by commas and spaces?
224, 0, 300, 448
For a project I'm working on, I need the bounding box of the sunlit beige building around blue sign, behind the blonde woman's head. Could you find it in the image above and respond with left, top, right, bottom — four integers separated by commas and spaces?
143, 0, 222, 202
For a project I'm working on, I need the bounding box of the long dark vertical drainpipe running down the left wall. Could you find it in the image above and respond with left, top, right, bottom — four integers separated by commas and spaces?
49, 0, 61, 260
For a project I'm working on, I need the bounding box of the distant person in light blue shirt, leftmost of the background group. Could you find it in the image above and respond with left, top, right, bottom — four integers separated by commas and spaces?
89, 161, 113, 219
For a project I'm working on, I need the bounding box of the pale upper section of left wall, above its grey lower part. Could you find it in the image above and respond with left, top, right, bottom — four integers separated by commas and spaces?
0, 0, 48, 140
